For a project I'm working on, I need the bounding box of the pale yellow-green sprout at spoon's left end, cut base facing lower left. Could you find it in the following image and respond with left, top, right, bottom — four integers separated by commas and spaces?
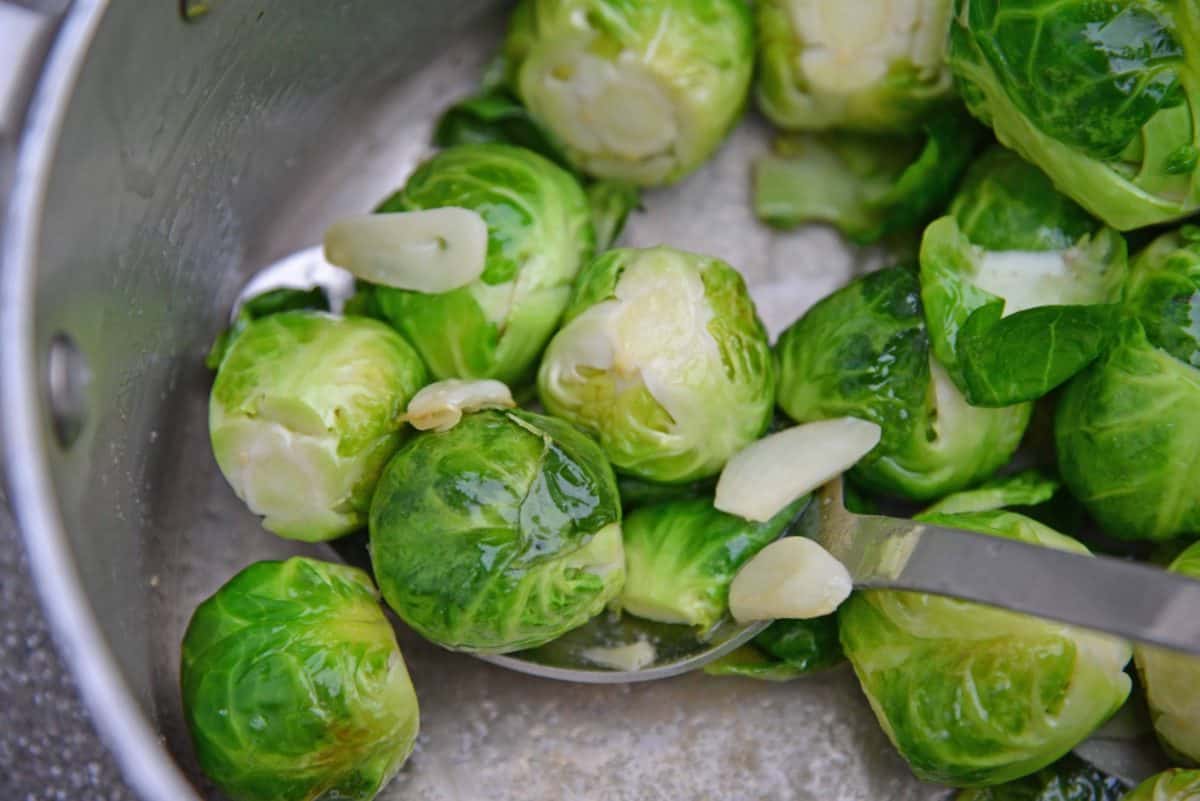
209, 311, 428, 541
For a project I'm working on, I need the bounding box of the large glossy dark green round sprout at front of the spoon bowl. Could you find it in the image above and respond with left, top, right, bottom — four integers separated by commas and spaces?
371, 410, 625, 654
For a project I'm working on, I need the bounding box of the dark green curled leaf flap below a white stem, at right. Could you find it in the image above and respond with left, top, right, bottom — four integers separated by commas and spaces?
958, 303, 1121, 406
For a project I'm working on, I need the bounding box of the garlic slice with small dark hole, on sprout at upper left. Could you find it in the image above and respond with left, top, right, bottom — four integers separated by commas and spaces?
325, 206, 487, 294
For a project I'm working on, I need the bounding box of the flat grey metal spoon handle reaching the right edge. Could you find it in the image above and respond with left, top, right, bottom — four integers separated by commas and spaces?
820, 499, 1200, 655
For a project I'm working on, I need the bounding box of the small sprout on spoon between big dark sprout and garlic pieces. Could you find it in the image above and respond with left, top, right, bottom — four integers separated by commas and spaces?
620, 498, 808, 636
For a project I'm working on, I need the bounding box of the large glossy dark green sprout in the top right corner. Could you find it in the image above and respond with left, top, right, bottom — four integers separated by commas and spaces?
949, 0, 1200, 230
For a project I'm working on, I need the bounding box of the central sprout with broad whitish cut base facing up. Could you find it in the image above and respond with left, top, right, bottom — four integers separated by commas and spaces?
538, 247, 775, 483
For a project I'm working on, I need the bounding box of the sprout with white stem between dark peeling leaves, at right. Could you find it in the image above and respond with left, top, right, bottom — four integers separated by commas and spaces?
920, 147, 1127, 406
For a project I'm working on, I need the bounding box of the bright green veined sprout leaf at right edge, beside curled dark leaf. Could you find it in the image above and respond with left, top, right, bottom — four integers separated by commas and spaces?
1055, 320, 1200, 541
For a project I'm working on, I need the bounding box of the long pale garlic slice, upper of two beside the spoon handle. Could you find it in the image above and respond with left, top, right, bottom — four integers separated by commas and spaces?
713, 417, 882, 522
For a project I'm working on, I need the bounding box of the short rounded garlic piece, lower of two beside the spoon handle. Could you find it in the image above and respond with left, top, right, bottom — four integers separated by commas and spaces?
730, 537, 853, 624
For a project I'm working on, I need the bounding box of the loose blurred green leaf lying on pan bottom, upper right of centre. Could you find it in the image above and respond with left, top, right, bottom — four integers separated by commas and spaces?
754, 106, 985, 245
